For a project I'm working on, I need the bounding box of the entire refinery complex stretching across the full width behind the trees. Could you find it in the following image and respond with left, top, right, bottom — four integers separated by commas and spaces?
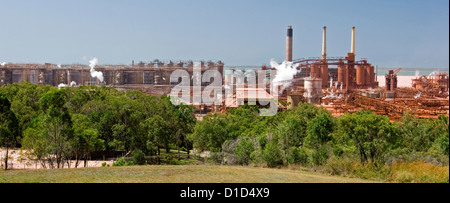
0, 26, 449, 120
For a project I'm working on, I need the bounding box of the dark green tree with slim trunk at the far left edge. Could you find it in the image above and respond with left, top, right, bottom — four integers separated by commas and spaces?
0, 92, 19, 170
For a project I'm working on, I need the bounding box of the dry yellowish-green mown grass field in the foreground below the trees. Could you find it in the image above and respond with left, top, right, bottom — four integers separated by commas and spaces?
0, 165, 376, 183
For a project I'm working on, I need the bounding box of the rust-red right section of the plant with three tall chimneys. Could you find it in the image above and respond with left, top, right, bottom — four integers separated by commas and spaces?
281, 26, 449, 120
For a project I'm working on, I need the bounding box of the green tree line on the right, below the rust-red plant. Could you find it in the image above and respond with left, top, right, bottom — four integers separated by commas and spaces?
189, 98, 449, 168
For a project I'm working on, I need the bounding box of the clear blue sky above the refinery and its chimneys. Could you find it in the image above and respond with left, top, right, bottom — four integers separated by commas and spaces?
0, 0, 449, 69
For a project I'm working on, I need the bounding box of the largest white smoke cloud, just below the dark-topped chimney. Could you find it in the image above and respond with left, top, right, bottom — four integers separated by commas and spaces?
270, 59, 301, 89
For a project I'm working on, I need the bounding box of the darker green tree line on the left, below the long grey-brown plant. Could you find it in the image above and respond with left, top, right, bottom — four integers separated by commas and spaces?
0, 82, 195, 168
